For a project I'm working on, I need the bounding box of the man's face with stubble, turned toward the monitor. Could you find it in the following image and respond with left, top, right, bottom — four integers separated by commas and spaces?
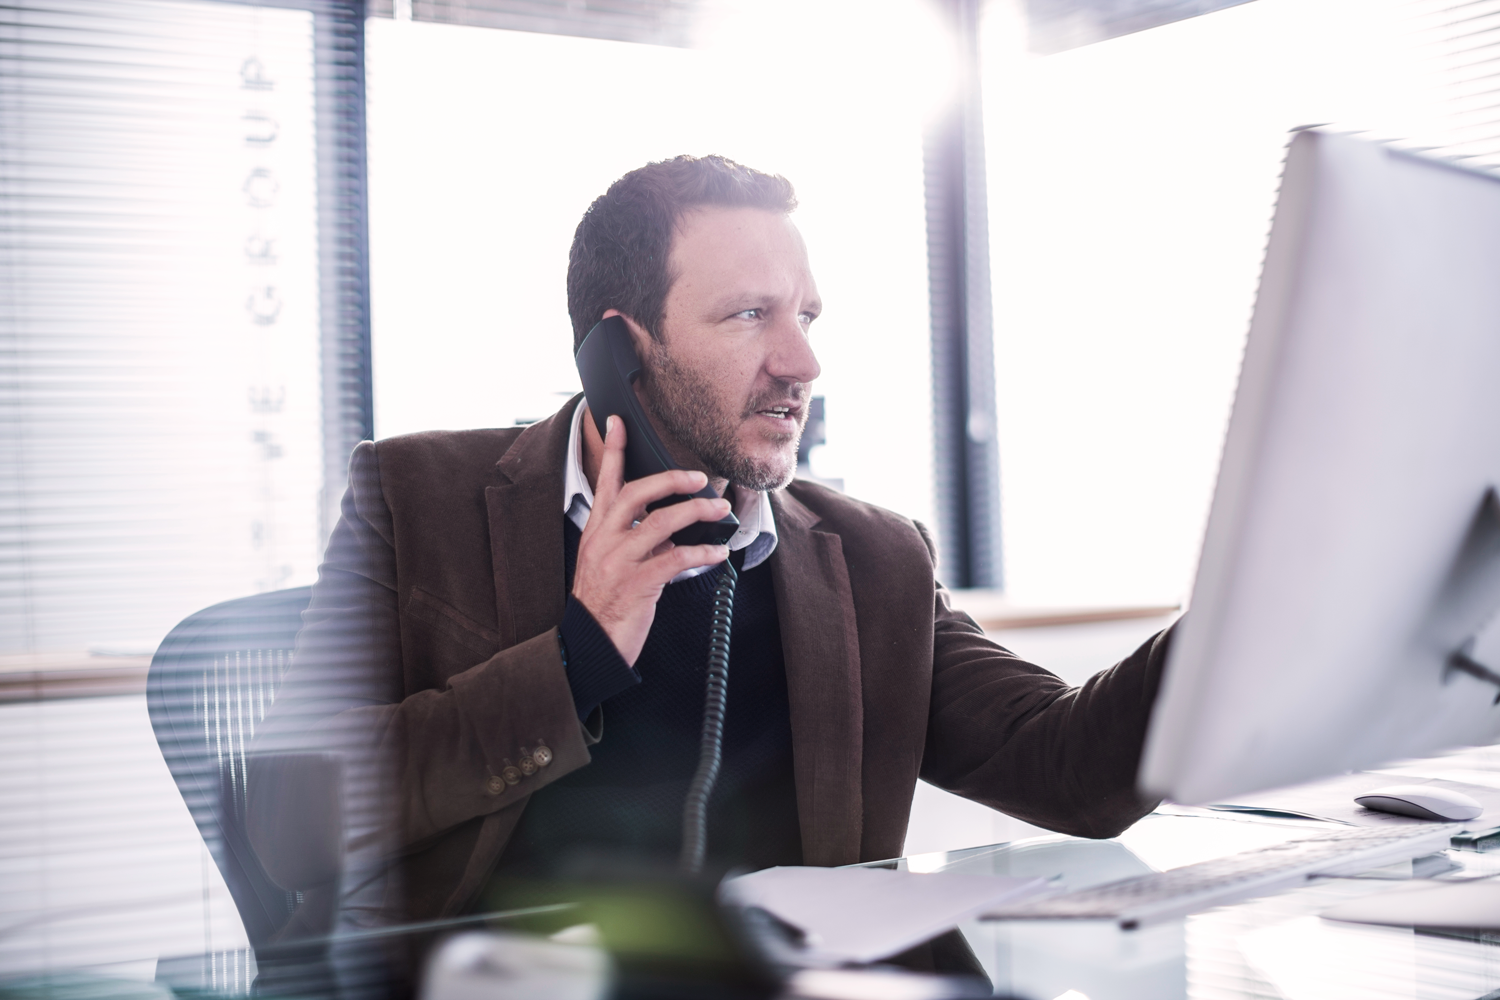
632, 208, 822, 490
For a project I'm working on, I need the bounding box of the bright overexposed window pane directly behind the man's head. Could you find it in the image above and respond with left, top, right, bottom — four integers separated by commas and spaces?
369, 0, 945, 520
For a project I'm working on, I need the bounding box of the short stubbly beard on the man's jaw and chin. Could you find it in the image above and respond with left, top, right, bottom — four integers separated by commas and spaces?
641, 340, 809, 490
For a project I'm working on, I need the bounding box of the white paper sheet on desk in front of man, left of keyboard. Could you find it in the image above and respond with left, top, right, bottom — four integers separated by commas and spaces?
723, 868, 1046, 963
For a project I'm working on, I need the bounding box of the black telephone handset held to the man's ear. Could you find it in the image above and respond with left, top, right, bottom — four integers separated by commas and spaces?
575, 316, 740, 546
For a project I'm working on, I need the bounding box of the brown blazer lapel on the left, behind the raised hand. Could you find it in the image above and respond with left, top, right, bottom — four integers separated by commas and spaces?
485, 396, 582, 646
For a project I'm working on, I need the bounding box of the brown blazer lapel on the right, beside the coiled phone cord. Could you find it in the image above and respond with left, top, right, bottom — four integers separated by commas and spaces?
771, 490, 864, 865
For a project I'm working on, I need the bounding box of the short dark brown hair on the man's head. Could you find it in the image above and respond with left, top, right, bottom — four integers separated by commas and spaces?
567, 156, 797, 351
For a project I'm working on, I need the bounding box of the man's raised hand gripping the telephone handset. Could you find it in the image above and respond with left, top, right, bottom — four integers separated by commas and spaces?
573, 417, 729, 666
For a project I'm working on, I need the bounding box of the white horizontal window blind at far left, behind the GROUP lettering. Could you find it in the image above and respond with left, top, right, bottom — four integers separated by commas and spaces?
0, 0, 368, 655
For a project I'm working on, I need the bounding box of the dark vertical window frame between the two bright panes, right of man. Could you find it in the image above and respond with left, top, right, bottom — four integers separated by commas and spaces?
923, 0, 1005, 589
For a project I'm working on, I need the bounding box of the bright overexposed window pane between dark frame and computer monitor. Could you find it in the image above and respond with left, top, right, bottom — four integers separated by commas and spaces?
984, 0, 1434, 604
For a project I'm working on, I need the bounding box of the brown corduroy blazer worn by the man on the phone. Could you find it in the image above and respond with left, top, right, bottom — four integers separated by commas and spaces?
251, 397, 1169, 919
